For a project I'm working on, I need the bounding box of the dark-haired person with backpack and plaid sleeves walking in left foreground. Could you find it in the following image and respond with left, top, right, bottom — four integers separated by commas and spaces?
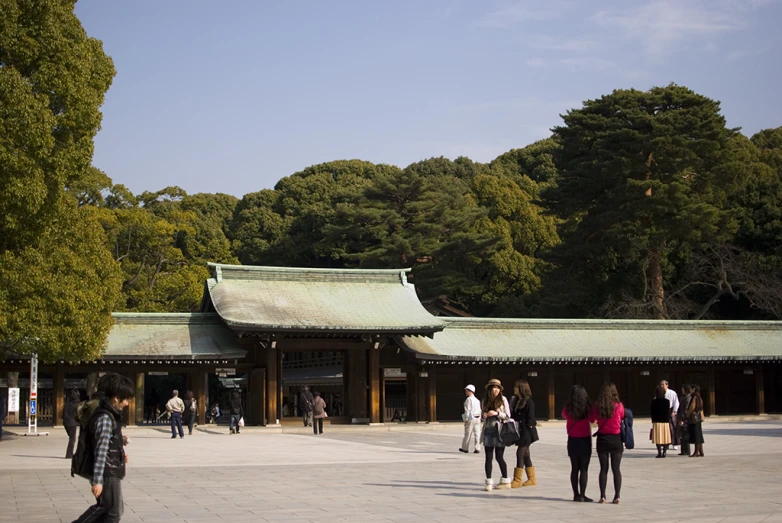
76, 373, 135, 523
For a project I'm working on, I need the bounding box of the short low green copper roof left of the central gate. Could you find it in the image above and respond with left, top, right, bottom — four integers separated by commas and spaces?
104, 312, 247, 360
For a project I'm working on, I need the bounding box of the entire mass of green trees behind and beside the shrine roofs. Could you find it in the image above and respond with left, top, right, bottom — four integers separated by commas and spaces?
0, 5, 782, 368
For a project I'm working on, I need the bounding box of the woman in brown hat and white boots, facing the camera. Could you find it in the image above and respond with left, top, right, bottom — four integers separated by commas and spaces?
481, 379, 510, 492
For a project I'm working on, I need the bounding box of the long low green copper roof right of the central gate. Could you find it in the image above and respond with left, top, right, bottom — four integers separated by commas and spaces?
397, 318, 782, 362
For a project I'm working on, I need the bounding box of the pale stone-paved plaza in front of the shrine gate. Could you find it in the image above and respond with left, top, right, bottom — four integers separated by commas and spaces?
0, 419, 782, 523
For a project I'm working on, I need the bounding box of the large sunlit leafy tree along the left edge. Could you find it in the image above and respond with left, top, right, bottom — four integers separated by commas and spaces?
0, 0, 119, 360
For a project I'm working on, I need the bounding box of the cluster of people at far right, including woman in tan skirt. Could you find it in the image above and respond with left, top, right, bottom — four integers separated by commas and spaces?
650, 380, 703, 458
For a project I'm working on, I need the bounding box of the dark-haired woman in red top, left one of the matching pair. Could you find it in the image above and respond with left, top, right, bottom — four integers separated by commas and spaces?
562, 385, 592, 501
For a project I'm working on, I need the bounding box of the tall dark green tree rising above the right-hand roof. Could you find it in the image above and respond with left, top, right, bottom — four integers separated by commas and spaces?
546, 85, 737, 318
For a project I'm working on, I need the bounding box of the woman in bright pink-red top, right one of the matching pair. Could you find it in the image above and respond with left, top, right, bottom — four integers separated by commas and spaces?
590, 382, 625, 505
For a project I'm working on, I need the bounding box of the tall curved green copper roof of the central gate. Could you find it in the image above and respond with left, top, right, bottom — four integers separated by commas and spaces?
202, 263, 444, 335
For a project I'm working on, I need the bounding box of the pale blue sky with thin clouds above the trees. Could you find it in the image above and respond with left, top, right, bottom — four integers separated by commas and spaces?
76, 0, 782, 196
